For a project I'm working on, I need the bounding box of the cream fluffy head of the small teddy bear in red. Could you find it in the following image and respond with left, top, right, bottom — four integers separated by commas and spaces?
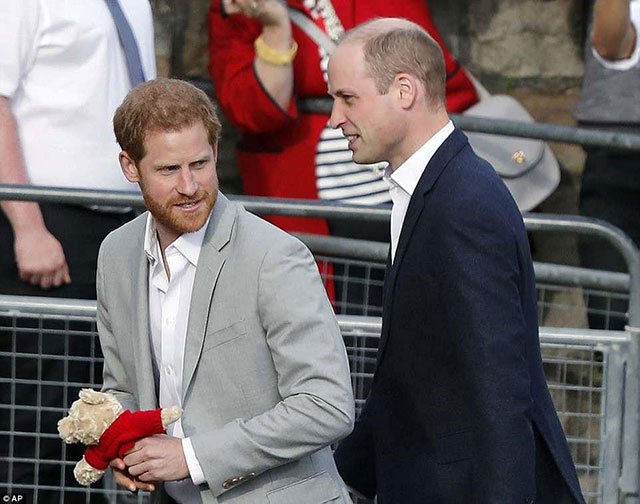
58, 389, 122, 445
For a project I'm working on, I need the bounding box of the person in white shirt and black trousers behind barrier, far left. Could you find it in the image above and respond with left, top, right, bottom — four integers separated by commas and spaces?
0, 0, 156, 502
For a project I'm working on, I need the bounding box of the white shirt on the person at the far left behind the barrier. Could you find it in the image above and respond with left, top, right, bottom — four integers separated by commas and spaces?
0, 0, 156, 191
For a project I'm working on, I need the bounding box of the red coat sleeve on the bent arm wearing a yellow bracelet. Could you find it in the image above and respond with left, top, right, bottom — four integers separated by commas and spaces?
209, 0, 298, 133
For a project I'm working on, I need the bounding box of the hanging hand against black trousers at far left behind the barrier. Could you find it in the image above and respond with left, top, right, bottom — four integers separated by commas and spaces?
14, 227, 71, 289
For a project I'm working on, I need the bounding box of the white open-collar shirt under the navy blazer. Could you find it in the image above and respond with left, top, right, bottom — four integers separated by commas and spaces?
384, 121, 454, 263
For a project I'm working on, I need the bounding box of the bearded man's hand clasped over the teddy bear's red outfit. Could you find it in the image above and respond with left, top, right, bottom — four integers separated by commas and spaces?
124, 434, 189, 482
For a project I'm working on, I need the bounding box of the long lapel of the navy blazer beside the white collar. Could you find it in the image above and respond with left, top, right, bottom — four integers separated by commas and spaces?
378, 128, 468, 363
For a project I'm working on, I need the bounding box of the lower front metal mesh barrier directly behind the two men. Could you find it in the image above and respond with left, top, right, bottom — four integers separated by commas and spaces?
0, 296, 637, 504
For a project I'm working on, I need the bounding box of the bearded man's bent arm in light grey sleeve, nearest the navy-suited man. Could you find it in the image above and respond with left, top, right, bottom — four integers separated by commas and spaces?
189, 237, 354, 496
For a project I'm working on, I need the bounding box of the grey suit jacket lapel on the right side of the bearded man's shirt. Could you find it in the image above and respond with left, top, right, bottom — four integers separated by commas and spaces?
182, 193, 237, 401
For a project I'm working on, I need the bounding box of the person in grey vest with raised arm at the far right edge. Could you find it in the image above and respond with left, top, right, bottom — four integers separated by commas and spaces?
574, 0, 640, 331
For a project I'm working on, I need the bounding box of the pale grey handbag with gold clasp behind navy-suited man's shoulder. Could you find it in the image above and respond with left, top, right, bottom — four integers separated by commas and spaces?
463, 92, 560, 212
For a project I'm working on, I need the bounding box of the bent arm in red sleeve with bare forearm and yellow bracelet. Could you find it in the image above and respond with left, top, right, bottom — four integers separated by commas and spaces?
209, 0, 297, 133
